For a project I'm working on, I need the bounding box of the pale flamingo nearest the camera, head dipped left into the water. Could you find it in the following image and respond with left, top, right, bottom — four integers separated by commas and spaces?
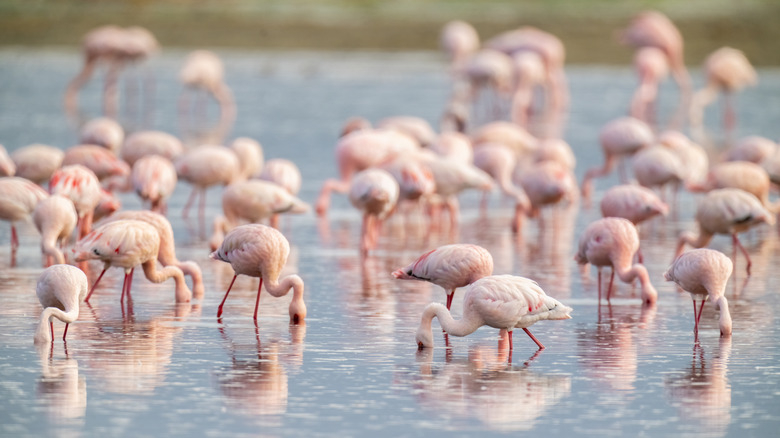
416, 275, 572, 357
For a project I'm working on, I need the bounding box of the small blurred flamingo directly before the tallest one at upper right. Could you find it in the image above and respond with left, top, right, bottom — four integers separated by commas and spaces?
630, 46, 669, 124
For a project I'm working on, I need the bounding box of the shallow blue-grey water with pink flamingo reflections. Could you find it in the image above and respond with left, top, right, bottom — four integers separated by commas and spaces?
0, 49, 780, 436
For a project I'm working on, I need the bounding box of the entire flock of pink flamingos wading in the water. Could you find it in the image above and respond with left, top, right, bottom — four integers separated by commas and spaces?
0, 11, 780, 361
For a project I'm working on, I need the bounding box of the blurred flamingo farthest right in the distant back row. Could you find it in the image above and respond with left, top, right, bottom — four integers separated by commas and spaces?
690, 47, 758, 133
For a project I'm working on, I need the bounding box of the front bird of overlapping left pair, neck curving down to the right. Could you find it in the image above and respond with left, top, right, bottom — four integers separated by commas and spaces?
73, 219, 192, 303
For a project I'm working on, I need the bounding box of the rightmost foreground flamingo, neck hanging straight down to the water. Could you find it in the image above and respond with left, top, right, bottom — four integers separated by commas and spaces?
664, 248, 734, 336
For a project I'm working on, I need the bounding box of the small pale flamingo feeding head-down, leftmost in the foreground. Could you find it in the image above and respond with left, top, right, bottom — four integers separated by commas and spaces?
34, 265, 89, 344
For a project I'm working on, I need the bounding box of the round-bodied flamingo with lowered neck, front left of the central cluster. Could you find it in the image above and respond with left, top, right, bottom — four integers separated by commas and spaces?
349, 169, 400, 253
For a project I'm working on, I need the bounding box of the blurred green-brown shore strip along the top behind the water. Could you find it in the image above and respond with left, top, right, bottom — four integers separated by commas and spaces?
0, 0, 780, 66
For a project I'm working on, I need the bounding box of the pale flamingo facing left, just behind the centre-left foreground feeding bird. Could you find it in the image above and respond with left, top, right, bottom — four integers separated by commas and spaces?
209, 180, 311, 251
